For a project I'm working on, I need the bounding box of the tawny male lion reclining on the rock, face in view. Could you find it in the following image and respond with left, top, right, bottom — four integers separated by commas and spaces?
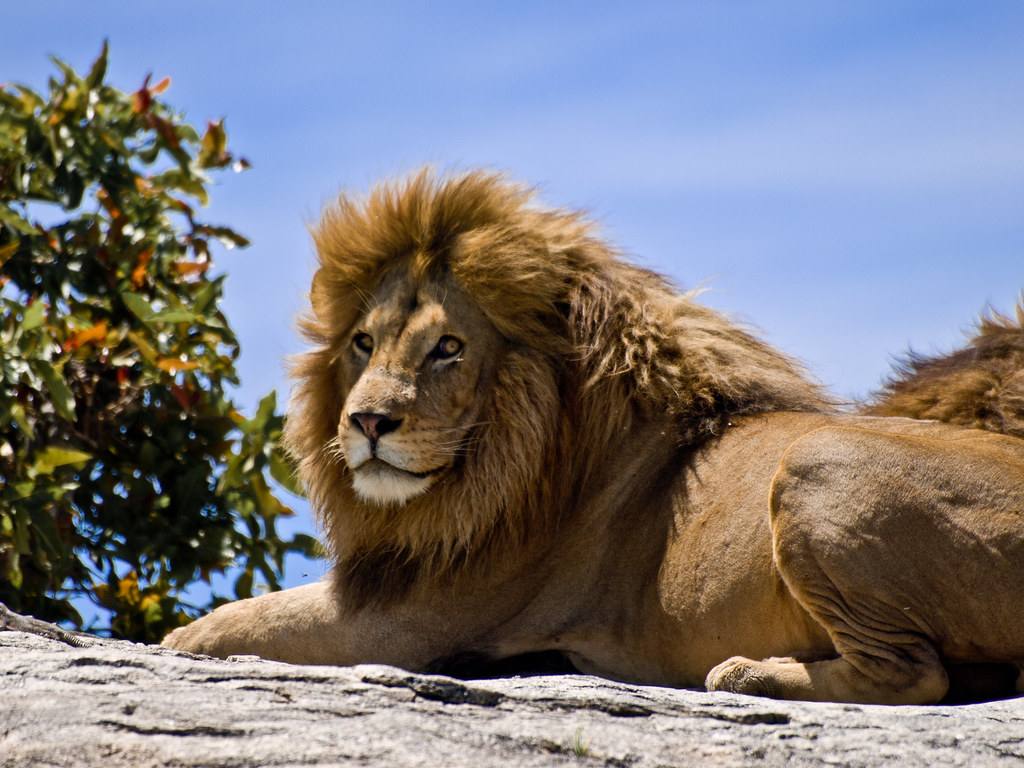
157, 169, 1024, 705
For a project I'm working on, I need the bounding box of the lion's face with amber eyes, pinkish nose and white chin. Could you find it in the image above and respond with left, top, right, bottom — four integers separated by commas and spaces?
338, 271, 503, 505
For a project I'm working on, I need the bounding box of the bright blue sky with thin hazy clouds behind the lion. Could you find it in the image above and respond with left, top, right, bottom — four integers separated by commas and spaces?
0, 0, 1024, 584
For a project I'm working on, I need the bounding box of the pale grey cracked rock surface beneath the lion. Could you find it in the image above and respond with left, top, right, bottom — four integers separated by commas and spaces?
0, 632, 1024, 768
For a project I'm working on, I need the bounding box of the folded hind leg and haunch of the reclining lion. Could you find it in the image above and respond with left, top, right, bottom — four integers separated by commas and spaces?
707, 427, 1024, 703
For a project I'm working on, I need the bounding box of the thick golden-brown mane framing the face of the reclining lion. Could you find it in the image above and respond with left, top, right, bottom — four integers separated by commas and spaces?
286, 169, 830, 601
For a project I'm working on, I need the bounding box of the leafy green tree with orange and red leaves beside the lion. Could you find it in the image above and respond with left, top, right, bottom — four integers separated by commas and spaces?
0, 44, 315, 641
